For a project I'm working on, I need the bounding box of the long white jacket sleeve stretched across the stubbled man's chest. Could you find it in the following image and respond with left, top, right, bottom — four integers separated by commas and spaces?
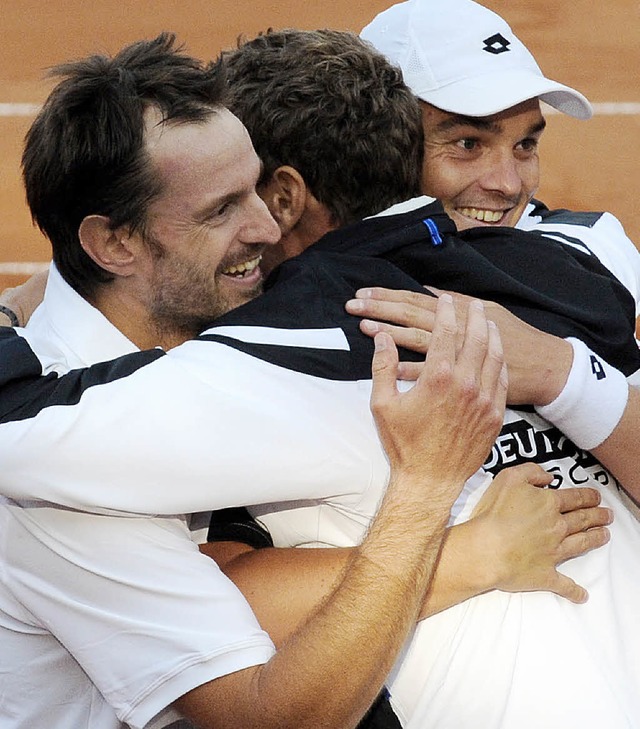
0, 340, 388, 514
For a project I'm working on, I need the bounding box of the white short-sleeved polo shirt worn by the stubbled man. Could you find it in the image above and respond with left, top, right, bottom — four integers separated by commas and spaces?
0, 269, 274, 729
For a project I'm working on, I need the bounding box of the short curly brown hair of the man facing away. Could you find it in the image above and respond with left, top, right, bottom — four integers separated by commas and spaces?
219, 30, 423, 225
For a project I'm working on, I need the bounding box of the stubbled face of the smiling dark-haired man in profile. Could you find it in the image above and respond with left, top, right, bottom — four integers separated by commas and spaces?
139, 109, 280, 333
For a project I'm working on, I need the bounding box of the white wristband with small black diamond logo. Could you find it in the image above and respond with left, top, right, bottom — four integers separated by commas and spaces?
536, 337, 629, 451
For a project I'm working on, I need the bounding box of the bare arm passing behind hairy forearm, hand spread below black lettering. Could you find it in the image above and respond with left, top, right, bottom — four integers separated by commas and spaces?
201, 464, 611, 645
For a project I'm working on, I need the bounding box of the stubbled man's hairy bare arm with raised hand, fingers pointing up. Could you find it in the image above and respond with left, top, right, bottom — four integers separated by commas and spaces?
177, 301, 506, 729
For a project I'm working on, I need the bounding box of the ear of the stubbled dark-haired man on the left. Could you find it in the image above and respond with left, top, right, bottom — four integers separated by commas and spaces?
78, 215, 136, 276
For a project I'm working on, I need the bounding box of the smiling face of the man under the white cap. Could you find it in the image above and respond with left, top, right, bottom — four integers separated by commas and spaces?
422, 99, 545, 230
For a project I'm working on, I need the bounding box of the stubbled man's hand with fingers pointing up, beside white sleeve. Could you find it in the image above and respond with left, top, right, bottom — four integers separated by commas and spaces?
371, 295, 507, 501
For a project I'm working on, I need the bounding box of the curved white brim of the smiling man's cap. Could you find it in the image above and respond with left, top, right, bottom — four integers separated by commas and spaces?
404, 69, 593, 119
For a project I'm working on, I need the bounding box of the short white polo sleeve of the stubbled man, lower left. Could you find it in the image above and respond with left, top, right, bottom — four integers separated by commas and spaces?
0, 504, 274, 727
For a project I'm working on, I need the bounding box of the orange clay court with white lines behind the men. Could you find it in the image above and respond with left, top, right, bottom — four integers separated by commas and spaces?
0, 0, 640, 289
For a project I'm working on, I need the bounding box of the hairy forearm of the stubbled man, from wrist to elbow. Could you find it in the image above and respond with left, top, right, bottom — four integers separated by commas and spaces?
180, 472, 450, 729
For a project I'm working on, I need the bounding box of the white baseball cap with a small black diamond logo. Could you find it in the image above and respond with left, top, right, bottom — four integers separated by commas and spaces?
360, 0, 593, 119
